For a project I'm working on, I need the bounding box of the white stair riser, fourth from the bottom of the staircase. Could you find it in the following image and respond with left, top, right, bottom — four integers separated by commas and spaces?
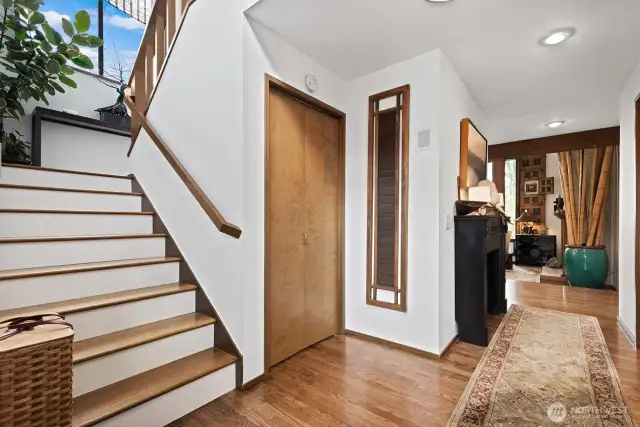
0, 262, 179, 310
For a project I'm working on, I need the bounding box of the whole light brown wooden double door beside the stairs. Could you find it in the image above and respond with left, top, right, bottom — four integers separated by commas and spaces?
265, 89, 344, 368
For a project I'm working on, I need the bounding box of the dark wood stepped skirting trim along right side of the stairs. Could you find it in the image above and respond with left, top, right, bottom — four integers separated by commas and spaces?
132, 175, 244, 389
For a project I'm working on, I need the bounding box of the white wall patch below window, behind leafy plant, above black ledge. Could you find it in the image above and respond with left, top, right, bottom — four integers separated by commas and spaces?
5, 71, 118, 145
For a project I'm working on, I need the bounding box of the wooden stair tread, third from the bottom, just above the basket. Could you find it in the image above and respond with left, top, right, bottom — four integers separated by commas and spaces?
0, 283, 198, 321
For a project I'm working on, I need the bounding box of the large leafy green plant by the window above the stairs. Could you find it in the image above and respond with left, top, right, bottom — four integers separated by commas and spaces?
0, 0, 102, 164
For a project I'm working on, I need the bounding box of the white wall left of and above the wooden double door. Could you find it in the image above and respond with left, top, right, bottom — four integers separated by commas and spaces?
241, 17, 348, 382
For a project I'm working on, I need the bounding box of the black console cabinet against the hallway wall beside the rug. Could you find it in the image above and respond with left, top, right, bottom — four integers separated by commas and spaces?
455, 216, 507, 346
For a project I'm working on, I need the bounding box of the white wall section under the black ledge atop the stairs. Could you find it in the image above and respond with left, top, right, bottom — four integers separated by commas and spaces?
41, 121, 132, 175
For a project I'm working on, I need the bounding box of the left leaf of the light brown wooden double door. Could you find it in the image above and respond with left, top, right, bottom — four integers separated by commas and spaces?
266, 91, 307, 366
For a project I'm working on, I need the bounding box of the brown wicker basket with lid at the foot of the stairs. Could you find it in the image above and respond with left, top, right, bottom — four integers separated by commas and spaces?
0, 314, 73, 427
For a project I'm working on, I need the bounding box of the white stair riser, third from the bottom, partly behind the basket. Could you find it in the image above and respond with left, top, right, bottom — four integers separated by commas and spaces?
67, 291, 196, 341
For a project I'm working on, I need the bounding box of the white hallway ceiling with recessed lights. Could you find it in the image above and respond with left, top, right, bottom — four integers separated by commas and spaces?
248, 0, 640, 143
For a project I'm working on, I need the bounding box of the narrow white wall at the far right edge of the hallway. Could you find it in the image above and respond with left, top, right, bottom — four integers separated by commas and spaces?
618, 58, 640, 340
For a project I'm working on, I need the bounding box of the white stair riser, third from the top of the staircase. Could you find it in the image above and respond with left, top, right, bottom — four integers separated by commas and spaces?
0, 212, 153, 238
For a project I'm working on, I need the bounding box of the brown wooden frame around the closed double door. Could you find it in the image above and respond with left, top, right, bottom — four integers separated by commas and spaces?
264, 74, 347, 373
